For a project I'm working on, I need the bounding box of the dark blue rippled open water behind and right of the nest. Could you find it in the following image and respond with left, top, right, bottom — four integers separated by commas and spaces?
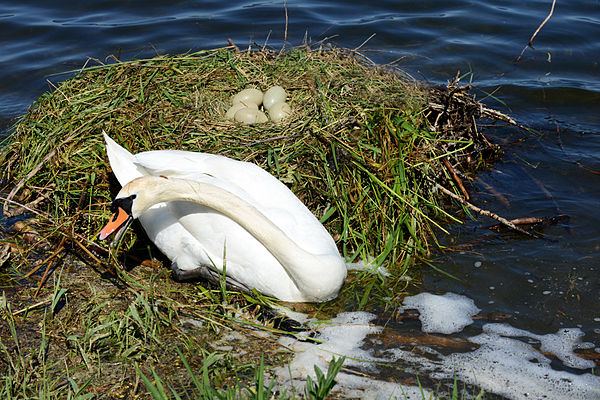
0, 0, 600, 396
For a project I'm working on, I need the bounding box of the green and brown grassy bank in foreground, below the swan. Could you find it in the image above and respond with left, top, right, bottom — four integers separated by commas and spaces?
0, 271, 481, 400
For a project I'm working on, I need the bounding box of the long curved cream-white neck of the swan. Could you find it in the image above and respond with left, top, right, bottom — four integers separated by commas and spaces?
129, 176, 346, 301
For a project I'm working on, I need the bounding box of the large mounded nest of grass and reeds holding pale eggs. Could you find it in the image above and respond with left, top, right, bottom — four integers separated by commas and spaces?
0, 47, 497, 298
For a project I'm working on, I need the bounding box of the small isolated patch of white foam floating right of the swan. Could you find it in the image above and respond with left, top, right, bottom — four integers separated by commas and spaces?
400, 293, 480, 334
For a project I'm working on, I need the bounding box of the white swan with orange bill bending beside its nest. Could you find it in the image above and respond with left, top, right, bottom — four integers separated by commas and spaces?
98, 134, 346, 301
